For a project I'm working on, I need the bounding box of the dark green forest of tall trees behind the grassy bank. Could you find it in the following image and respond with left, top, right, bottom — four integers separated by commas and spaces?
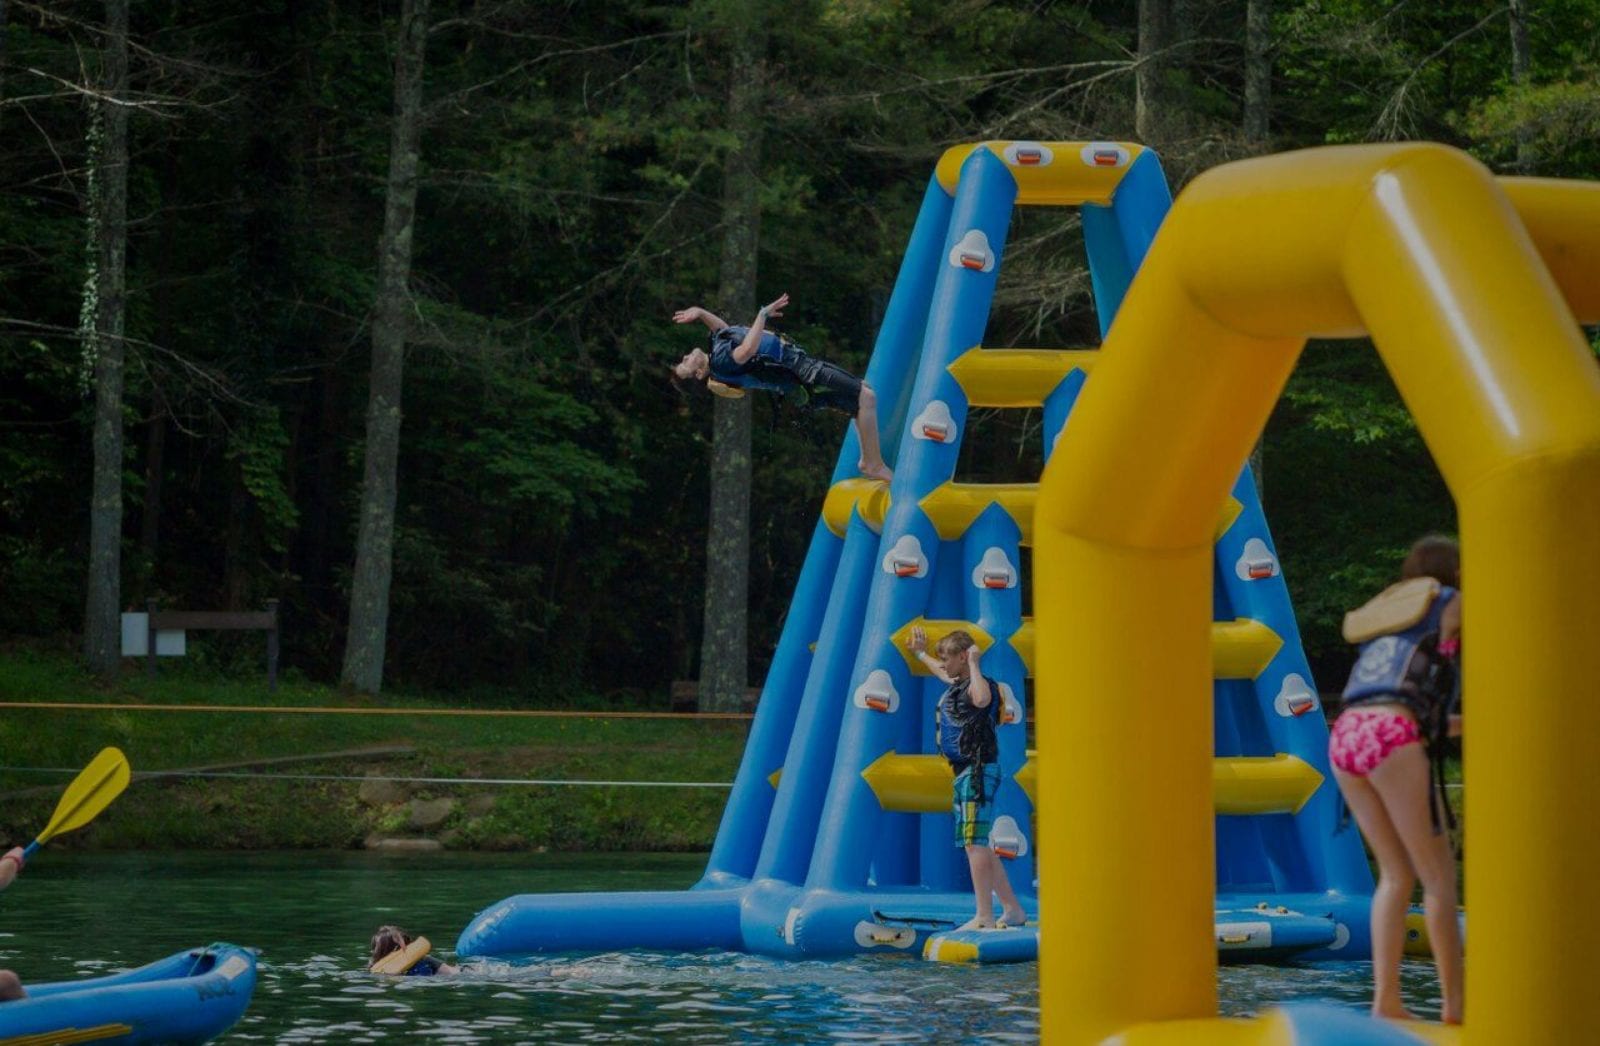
0, 0, 1600, 707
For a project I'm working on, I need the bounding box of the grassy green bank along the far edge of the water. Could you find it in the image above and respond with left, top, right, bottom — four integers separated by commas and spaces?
0, 649, 749, 851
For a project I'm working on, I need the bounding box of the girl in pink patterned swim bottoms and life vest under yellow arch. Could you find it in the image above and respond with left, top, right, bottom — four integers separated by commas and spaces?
1328, 536, 1462, 1024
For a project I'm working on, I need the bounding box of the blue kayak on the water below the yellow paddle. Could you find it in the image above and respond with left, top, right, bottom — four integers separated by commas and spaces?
0, 944, 256, 1046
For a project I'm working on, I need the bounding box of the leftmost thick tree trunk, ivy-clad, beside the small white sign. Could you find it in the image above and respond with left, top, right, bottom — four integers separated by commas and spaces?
83, 0, 128, 678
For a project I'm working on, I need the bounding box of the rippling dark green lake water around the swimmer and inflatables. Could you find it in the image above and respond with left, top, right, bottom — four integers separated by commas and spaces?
0, 849, 1438, 1043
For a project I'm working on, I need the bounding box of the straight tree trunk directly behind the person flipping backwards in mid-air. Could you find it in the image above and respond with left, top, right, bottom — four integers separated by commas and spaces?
699, 0, 766, 712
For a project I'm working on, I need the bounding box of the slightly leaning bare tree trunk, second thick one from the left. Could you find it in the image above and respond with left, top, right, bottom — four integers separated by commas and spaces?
341, 0, 429, 694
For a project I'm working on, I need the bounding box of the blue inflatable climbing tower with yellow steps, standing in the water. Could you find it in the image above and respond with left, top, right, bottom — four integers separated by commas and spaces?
456, 142, 1373, 961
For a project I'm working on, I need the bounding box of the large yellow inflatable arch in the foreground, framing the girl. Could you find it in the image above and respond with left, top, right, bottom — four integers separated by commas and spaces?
1035, 146, 1600, 1046
